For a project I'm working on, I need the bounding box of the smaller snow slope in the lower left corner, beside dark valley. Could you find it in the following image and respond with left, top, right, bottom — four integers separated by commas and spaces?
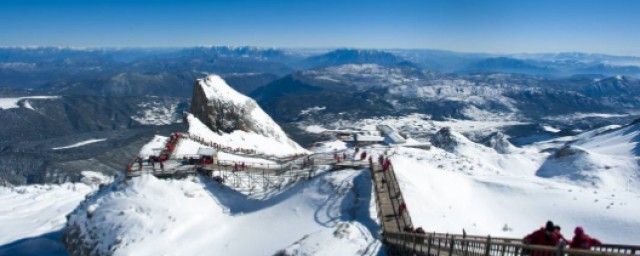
0, 172, 109, 255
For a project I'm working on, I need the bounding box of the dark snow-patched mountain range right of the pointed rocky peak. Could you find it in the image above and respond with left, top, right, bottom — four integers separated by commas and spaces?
250, 63, 640, 121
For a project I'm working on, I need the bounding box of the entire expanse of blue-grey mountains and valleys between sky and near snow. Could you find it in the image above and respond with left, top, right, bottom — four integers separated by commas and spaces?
0, 46, 640, 184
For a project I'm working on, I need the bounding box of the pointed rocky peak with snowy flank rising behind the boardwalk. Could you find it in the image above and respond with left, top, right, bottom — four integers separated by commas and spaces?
186, 75, 305, 154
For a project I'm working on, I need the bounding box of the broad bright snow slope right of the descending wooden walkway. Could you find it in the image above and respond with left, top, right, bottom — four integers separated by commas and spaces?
392, 124, 640, 244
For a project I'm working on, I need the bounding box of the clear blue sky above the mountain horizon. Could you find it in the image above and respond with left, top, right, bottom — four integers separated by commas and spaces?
0, 0, 640, 55
